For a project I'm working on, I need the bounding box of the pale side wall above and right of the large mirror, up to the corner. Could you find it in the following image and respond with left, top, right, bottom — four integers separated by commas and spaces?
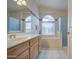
27, 0, 39, 34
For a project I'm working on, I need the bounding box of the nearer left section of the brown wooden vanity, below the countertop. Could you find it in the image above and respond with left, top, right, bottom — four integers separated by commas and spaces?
7, 41, 29, 59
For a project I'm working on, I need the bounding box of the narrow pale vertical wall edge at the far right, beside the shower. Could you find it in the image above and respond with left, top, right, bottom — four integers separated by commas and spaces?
67, 0, 72, 59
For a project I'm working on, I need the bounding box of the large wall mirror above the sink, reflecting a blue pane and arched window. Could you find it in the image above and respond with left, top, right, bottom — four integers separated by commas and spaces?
7, 0, 33, 33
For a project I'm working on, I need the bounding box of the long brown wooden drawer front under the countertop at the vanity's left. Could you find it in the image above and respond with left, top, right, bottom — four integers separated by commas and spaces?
8, 41, 29, 55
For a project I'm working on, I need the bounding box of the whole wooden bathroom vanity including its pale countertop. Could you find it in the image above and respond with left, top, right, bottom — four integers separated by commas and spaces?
7, 35, 39, 59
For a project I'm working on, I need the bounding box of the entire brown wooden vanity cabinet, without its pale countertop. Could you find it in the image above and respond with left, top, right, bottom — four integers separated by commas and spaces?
7, 37, 39, 59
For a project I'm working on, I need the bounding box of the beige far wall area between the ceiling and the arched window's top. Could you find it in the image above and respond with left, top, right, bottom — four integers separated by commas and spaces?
39, 6, 68, 18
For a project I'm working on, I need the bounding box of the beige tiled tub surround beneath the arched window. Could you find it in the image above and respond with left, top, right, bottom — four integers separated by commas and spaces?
40, 35, 61, 50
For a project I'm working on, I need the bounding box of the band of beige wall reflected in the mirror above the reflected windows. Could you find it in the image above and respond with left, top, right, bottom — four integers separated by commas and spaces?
7, 9, 32, 20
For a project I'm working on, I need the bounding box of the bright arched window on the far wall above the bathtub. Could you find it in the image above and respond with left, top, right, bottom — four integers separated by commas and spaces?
42, 15, 55, 35
